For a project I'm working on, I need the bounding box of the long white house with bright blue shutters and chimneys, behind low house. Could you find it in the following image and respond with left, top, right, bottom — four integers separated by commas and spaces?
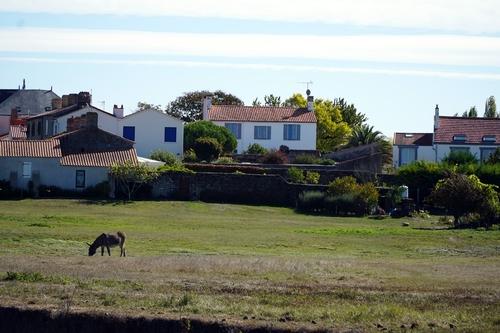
23, 93, 184, 157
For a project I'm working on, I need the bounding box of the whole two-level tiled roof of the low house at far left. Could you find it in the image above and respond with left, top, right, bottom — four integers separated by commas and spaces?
0, 129, 138, 167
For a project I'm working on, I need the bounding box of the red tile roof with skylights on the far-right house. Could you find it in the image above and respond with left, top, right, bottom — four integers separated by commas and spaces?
434, 117, 500, 145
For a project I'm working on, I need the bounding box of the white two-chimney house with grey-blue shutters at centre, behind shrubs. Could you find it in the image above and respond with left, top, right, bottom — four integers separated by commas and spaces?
203, 96, 316, 153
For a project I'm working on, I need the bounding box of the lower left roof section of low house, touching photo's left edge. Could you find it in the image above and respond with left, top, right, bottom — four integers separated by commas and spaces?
0, 140, 61, 158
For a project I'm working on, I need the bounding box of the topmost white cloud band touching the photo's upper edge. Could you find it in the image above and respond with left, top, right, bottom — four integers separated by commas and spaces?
0, 0, 500, 33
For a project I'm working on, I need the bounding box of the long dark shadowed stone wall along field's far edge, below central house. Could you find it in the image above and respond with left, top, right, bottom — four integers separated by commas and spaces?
152, 172, 327, 207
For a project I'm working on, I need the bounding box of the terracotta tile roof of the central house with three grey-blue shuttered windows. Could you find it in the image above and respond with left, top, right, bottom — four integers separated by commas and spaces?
208, 105, 316, 123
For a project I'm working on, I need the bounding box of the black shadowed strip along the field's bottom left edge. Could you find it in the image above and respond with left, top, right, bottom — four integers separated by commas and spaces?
0, 306, 327, 333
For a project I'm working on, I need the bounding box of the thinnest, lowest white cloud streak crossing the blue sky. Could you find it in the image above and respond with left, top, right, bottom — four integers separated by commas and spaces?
0, 57, 500, 81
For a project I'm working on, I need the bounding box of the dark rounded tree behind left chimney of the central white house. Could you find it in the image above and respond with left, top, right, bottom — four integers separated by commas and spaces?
165, 90, 243, 122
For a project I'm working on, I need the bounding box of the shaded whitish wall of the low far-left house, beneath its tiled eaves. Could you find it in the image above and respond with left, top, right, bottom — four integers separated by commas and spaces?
0, 157, 109, 190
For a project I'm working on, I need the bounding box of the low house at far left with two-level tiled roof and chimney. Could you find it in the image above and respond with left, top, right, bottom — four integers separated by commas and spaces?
0, 113, 138, 191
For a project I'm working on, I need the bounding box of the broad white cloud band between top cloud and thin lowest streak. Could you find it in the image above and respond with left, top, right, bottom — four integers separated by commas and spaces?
0, 28, 500, 67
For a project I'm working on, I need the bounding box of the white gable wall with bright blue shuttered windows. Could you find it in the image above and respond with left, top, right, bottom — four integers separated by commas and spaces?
116, 110, 184, 157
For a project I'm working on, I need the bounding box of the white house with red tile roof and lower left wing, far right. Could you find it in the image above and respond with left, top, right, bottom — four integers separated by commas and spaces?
393, 105, 500, 167
